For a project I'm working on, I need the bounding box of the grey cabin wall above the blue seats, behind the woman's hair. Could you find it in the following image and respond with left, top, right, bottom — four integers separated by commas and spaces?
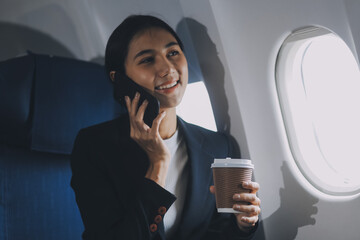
0, 0, 183, 63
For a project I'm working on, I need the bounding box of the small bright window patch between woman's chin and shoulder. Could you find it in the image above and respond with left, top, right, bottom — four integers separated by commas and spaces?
176, 81, 217, 131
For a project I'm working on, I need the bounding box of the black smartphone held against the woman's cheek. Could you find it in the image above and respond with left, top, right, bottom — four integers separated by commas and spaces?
114, 72, 160, 127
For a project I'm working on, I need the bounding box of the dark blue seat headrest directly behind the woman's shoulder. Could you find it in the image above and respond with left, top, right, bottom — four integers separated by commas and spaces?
31, 55, 125, 154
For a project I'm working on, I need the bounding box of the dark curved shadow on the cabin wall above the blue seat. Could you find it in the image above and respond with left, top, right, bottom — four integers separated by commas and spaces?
0, 22, 75, 61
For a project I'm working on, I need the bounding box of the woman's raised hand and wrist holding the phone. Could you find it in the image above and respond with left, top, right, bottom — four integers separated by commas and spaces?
125, 93, 170, 186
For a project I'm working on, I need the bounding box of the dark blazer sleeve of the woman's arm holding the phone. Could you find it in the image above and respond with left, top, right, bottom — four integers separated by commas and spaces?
71, 131, 176, 240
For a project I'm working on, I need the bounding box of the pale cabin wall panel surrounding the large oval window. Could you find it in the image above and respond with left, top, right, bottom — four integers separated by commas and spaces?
182, 0, 360, 240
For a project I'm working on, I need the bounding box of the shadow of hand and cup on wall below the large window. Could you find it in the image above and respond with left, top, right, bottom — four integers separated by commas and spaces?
255, 162, 319, 240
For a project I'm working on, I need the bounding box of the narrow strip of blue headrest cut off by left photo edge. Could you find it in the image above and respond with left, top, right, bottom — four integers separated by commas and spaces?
0, 55, 35, 146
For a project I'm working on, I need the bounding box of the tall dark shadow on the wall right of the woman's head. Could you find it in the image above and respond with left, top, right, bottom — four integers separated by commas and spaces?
176, 18, 230, 133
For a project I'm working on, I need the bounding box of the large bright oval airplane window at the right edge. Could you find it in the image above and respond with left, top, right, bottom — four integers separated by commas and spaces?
276, 27, 360, 195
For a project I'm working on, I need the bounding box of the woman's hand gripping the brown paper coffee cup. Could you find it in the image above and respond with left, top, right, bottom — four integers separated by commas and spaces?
210, 182, 261, 232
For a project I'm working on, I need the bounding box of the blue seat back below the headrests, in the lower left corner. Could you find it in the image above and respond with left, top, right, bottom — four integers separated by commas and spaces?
0, 144, 84, 240
